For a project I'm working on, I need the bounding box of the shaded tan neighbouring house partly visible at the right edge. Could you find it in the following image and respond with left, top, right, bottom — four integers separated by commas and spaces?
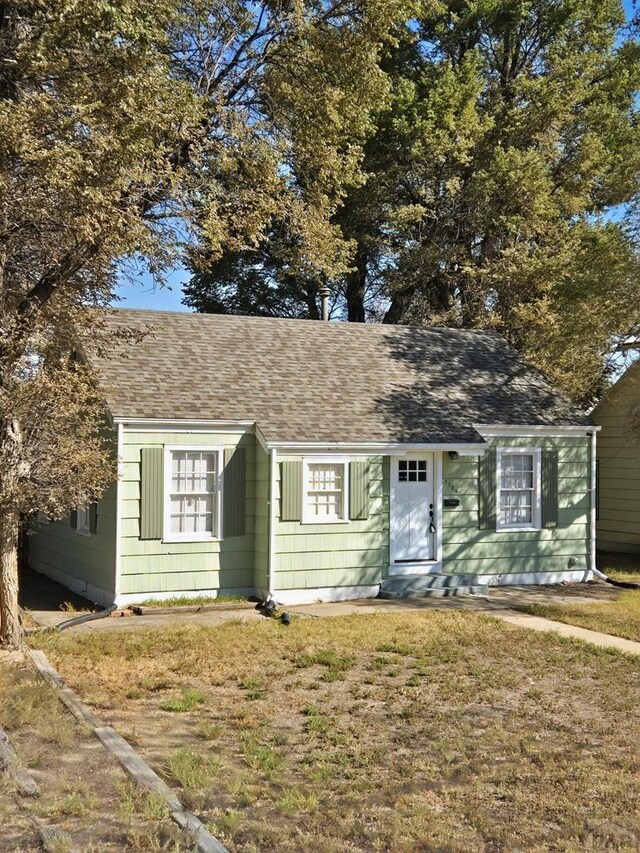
592, 362, 640, 554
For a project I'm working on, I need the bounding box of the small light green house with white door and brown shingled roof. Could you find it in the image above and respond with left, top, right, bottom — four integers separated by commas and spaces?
30, 310, 597, 604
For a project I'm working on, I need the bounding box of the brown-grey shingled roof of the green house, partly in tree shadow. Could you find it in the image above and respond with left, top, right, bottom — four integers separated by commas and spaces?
87, 309, 590, 444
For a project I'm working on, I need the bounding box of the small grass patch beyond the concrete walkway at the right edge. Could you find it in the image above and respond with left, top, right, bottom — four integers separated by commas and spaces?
522, 589, 640, 642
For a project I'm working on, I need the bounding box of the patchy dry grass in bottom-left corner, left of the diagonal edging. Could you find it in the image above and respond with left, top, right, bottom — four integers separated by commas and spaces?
0, 662, 188, 853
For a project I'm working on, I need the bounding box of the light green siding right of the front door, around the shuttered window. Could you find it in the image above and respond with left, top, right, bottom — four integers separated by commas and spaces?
442, 437, 591, 575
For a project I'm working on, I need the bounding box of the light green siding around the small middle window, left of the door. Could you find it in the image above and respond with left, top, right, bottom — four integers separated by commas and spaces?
275, 456, 389, 590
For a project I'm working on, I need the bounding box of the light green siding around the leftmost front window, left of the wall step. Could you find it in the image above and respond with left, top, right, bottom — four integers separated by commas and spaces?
121, 430, 258, 596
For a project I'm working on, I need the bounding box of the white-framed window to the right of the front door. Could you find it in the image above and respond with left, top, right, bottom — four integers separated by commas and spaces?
498, 448, 541, 530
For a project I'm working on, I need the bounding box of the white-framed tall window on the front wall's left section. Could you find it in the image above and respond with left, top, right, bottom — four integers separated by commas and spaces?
164, 447, 220, 541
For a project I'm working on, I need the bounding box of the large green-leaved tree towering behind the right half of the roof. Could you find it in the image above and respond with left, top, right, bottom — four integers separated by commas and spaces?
187, 0, 640, 400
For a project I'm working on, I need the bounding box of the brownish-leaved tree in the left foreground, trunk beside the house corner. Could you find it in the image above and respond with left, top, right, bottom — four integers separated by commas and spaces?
0, 0, 408, 646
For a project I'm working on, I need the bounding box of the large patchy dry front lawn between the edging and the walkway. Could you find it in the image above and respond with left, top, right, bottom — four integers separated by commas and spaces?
34, 612, 640, 853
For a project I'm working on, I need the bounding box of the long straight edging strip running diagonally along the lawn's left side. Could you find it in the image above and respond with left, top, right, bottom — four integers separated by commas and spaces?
28, 650, 228, 853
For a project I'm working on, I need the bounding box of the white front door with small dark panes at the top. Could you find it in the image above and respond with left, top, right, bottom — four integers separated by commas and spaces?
391, 453, 436, 572
